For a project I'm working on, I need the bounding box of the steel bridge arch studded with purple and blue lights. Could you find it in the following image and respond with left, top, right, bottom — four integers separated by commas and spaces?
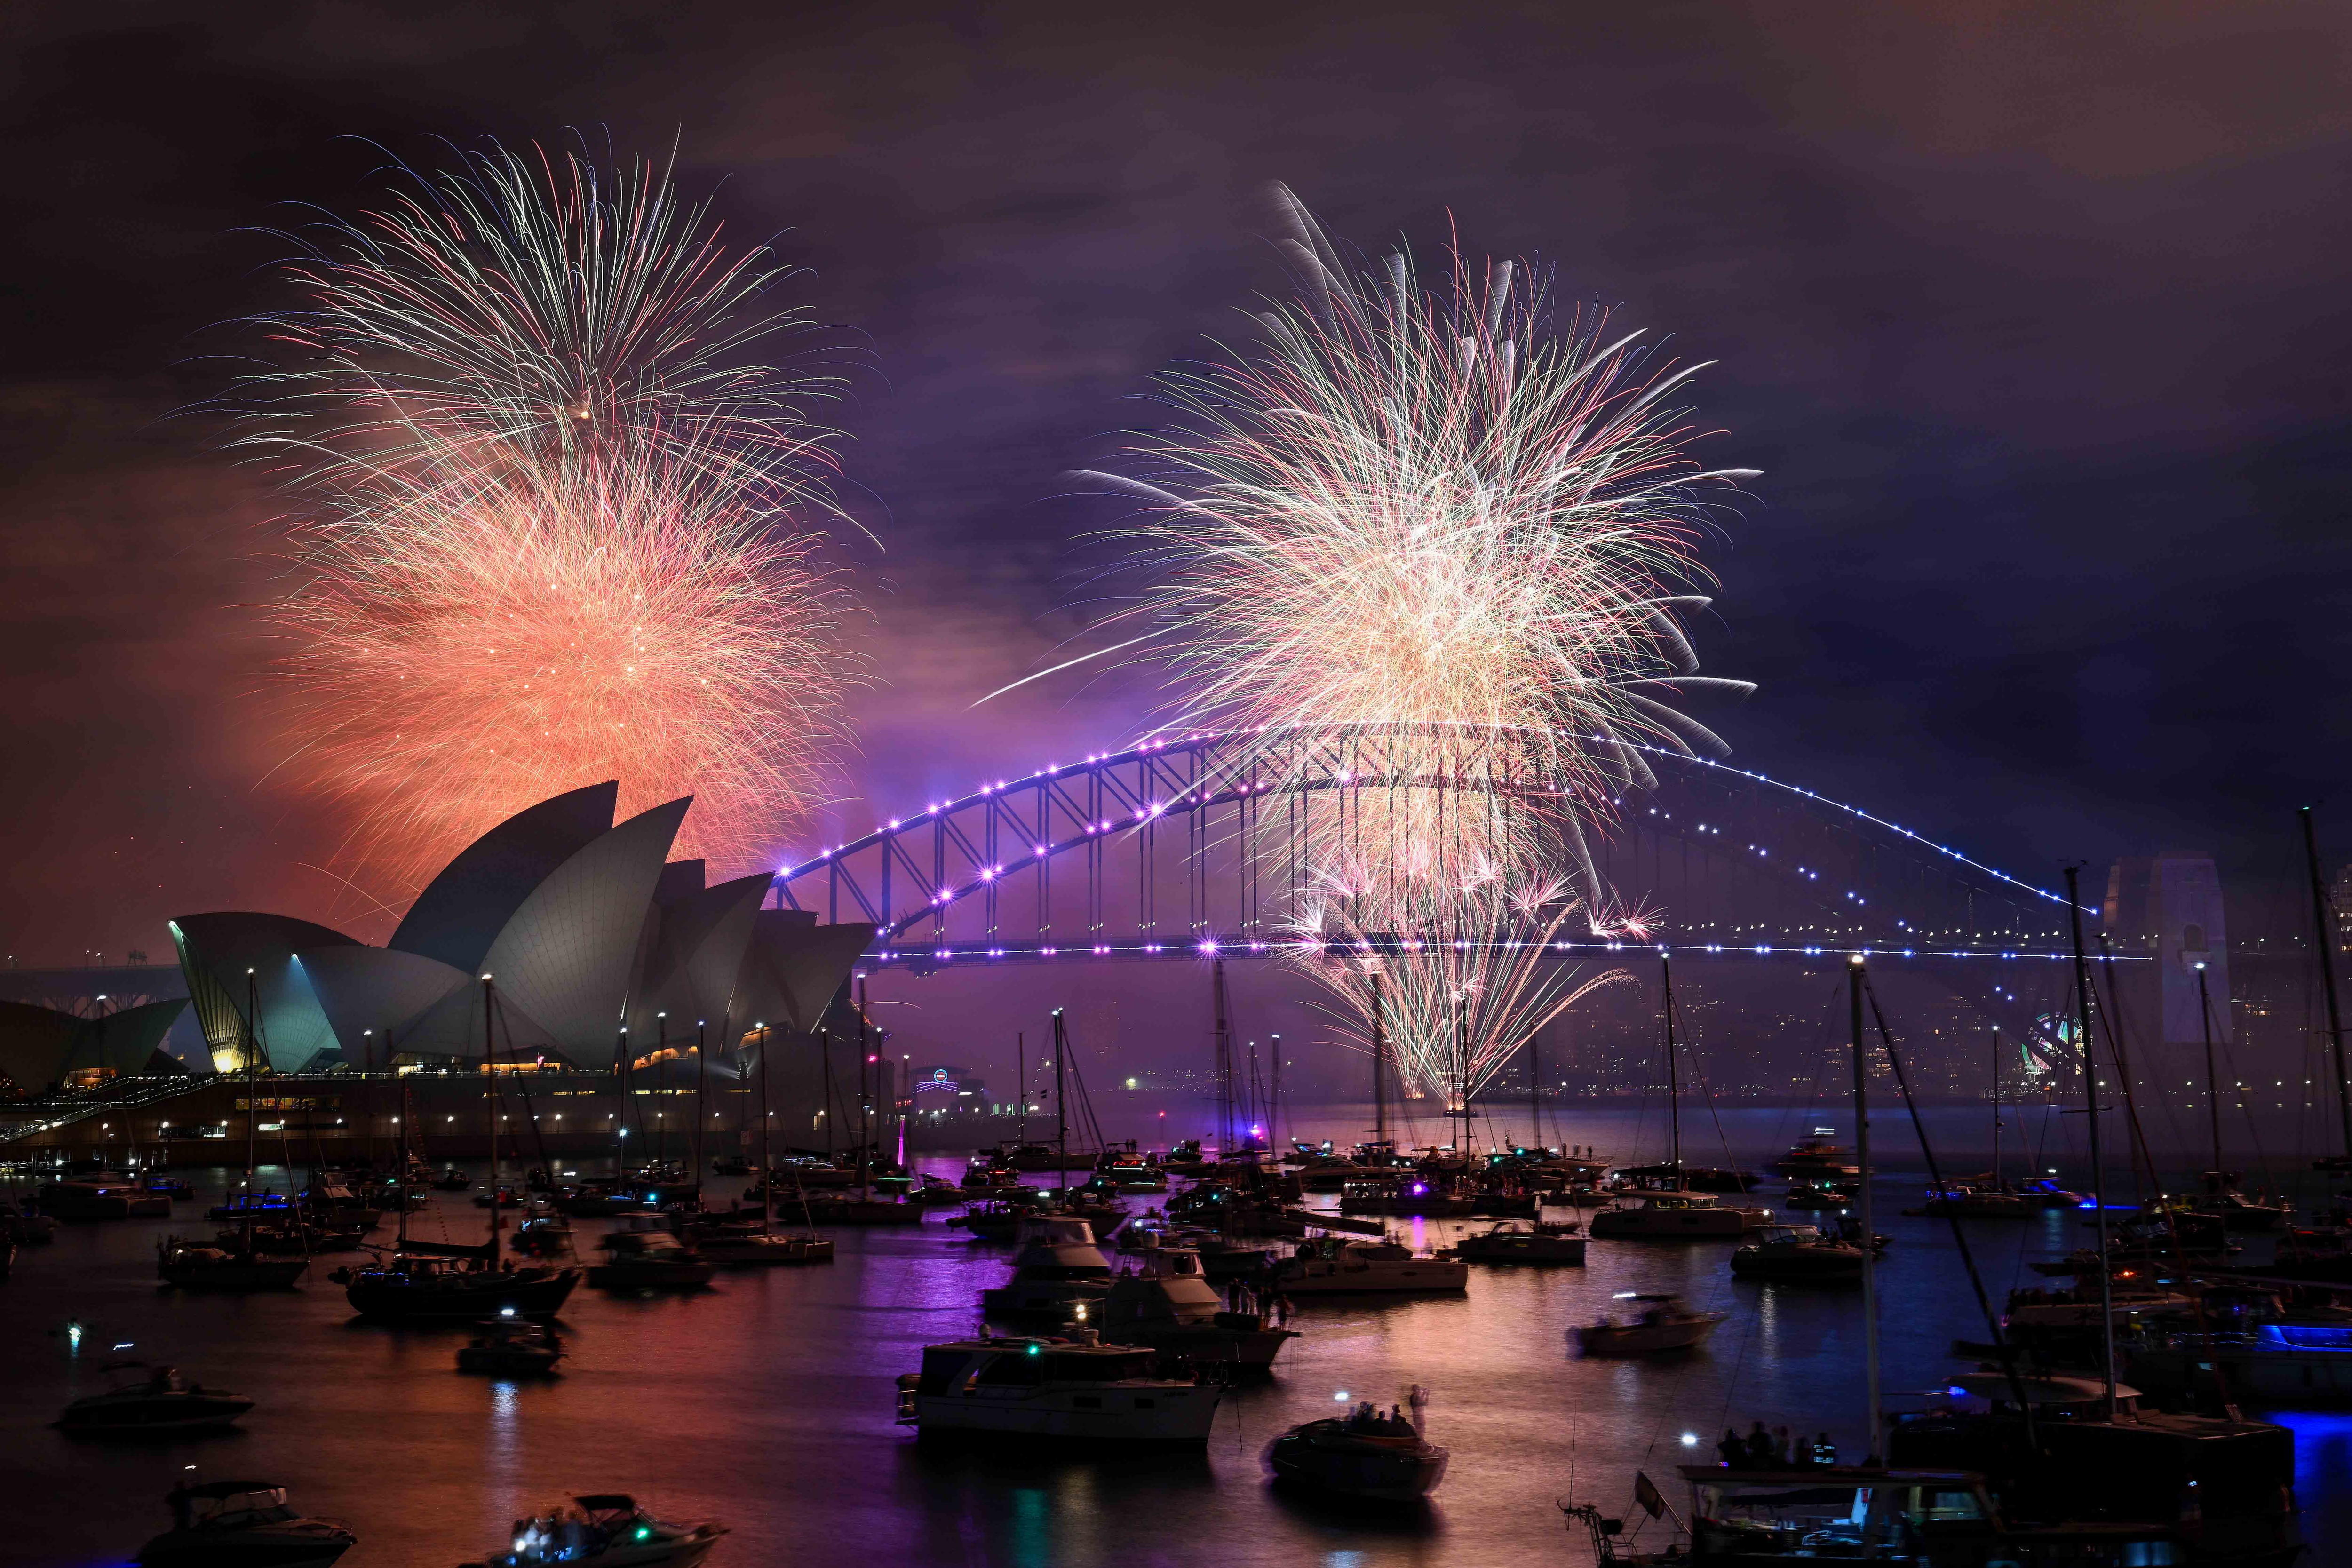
776, 726, 2098, 990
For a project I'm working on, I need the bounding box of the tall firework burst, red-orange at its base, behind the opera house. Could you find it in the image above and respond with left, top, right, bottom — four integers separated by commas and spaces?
240, 151, 861, 882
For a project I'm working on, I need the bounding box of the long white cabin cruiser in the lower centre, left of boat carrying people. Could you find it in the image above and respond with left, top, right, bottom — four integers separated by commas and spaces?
898, 1333, 1223, 1448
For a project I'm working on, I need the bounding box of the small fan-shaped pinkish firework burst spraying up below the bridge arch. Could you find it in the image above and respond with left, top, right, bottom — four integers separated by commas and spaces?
1294, 868, 1632, 1107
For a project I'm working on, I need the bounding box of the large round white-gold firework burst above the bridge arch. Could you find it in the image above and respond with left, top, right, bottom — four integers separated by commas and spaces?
1094, 205, 1750, 902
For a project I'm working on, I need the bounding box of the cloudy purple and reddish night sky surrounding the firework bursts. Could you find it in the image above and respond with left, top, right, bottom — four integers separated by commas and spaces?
0, 0, 2352, 964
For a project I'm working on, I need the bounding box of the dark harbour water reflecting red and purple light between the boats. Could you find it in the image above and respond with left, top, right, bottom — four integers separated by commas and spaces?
14, 1110, 2352, 1568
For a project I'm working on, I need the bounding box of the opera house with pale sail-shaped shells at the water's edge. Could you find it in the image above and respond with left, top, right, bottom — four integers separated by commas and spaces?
172, 783, 873, 1072
